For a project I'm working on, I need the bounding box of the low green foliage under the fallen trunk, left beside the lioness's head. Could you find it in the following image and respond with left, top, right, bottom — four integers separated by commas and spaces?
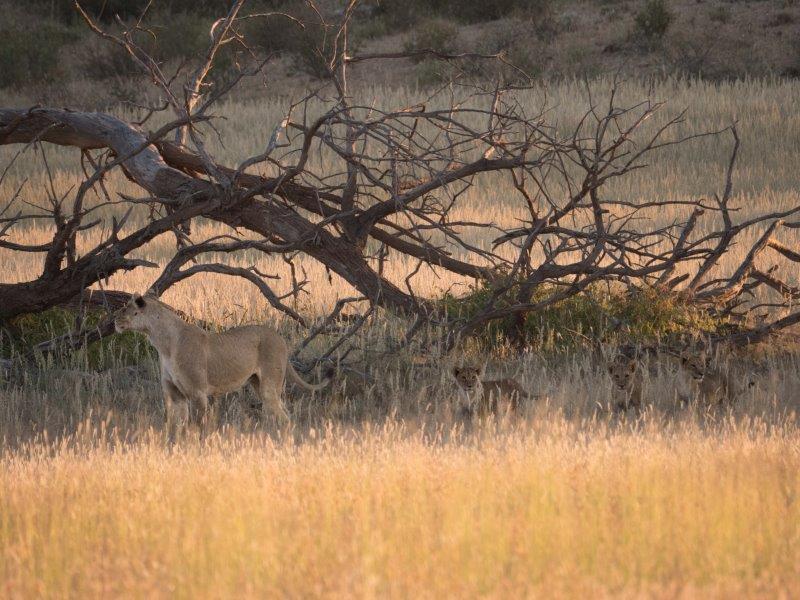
0, 308, 155, 369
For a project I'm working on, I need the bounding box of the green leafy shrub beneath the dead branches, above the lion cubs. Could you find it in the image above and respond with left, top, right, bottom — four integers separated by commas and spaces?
441, 286, 732, 350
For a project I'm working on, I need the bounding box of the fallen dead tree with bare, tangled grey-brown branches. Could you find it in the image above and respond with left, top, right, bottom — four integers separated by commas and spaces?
0, 0, 800, 366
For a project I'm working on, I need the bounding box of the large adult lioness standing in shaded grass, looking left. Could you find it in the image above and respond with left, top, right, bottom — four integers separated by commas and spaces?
114, 295, 330, 438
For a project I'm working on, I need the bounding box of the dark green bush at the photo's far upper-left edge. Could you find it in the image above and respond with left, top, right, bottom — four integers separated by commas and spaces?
0, 22, 77, 87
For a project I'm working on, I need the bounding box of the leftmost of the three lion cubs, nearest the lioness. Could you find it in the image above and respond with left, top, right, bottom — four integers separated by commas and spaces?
452, 364, 540, 418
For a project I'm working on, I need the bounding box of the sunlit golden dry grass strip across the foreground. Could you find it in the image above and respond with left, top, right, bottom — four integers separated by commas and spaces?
0, 419, 800, 598
